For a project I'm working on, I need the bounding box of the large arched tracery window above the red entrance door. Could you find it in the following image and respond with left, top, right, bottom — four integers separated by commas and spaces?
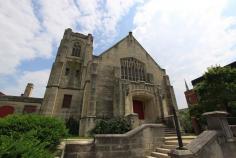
120, 57, 145, 81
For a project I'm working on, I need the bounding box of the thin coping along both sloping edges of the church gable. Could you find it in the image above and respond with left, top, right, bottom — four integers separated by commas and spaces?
97, 32, 164, 70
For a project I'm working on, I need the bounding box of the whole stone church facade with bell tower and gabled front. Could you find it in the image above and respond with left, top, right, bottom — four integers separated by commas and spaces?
40, 29, 177, 135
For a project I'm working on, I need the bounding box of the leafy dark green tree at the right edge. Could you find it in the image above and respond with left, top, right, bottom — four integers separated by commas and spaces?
195, 66, 236, 113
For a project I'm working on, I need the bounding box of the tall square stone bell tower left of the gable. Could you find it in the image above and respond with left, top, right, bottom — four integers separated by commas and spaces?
41, 28, 93, 119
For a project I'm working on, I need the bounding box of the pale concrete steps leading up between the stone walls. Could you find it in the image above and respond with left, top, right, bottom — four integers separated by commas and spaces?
146, 128, 197, 158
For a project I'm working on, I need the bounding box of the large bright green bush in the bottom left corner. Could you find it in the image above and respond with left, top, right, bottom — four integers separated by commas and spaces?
0, 115, 67, 158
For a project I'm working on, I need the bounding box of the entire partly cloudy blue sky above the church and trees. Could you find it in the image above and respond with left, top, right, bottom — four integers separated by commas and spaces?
0, 0, 236, 108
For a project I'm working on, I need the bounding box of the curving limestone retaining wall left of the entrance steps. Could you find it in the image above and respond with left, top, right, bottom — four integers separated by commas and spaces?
64, 124, 164, 158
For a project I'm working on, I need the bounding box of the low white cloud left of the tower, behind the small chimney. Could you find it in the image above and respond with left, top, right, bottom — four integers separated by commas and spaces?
2, 69, 50, 97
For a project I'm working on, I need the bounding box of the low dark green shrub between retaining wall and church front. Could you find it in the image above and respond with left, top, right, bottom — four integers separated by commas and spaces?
91, 117, 131, 135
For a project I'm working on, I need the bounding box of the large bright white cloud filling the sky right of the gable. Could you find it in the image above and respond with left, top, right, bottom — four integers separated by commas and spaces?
133, 0, 236, 108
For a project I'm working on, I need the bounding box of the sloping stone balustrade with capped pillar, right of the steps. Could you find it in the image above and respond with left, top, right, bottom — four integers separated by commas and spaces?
169, 111, 236, 158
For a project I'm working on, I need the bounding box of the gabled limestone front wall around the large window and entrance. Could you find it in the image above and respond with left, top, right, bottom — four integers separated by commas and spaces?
94, 34, 169, 119
